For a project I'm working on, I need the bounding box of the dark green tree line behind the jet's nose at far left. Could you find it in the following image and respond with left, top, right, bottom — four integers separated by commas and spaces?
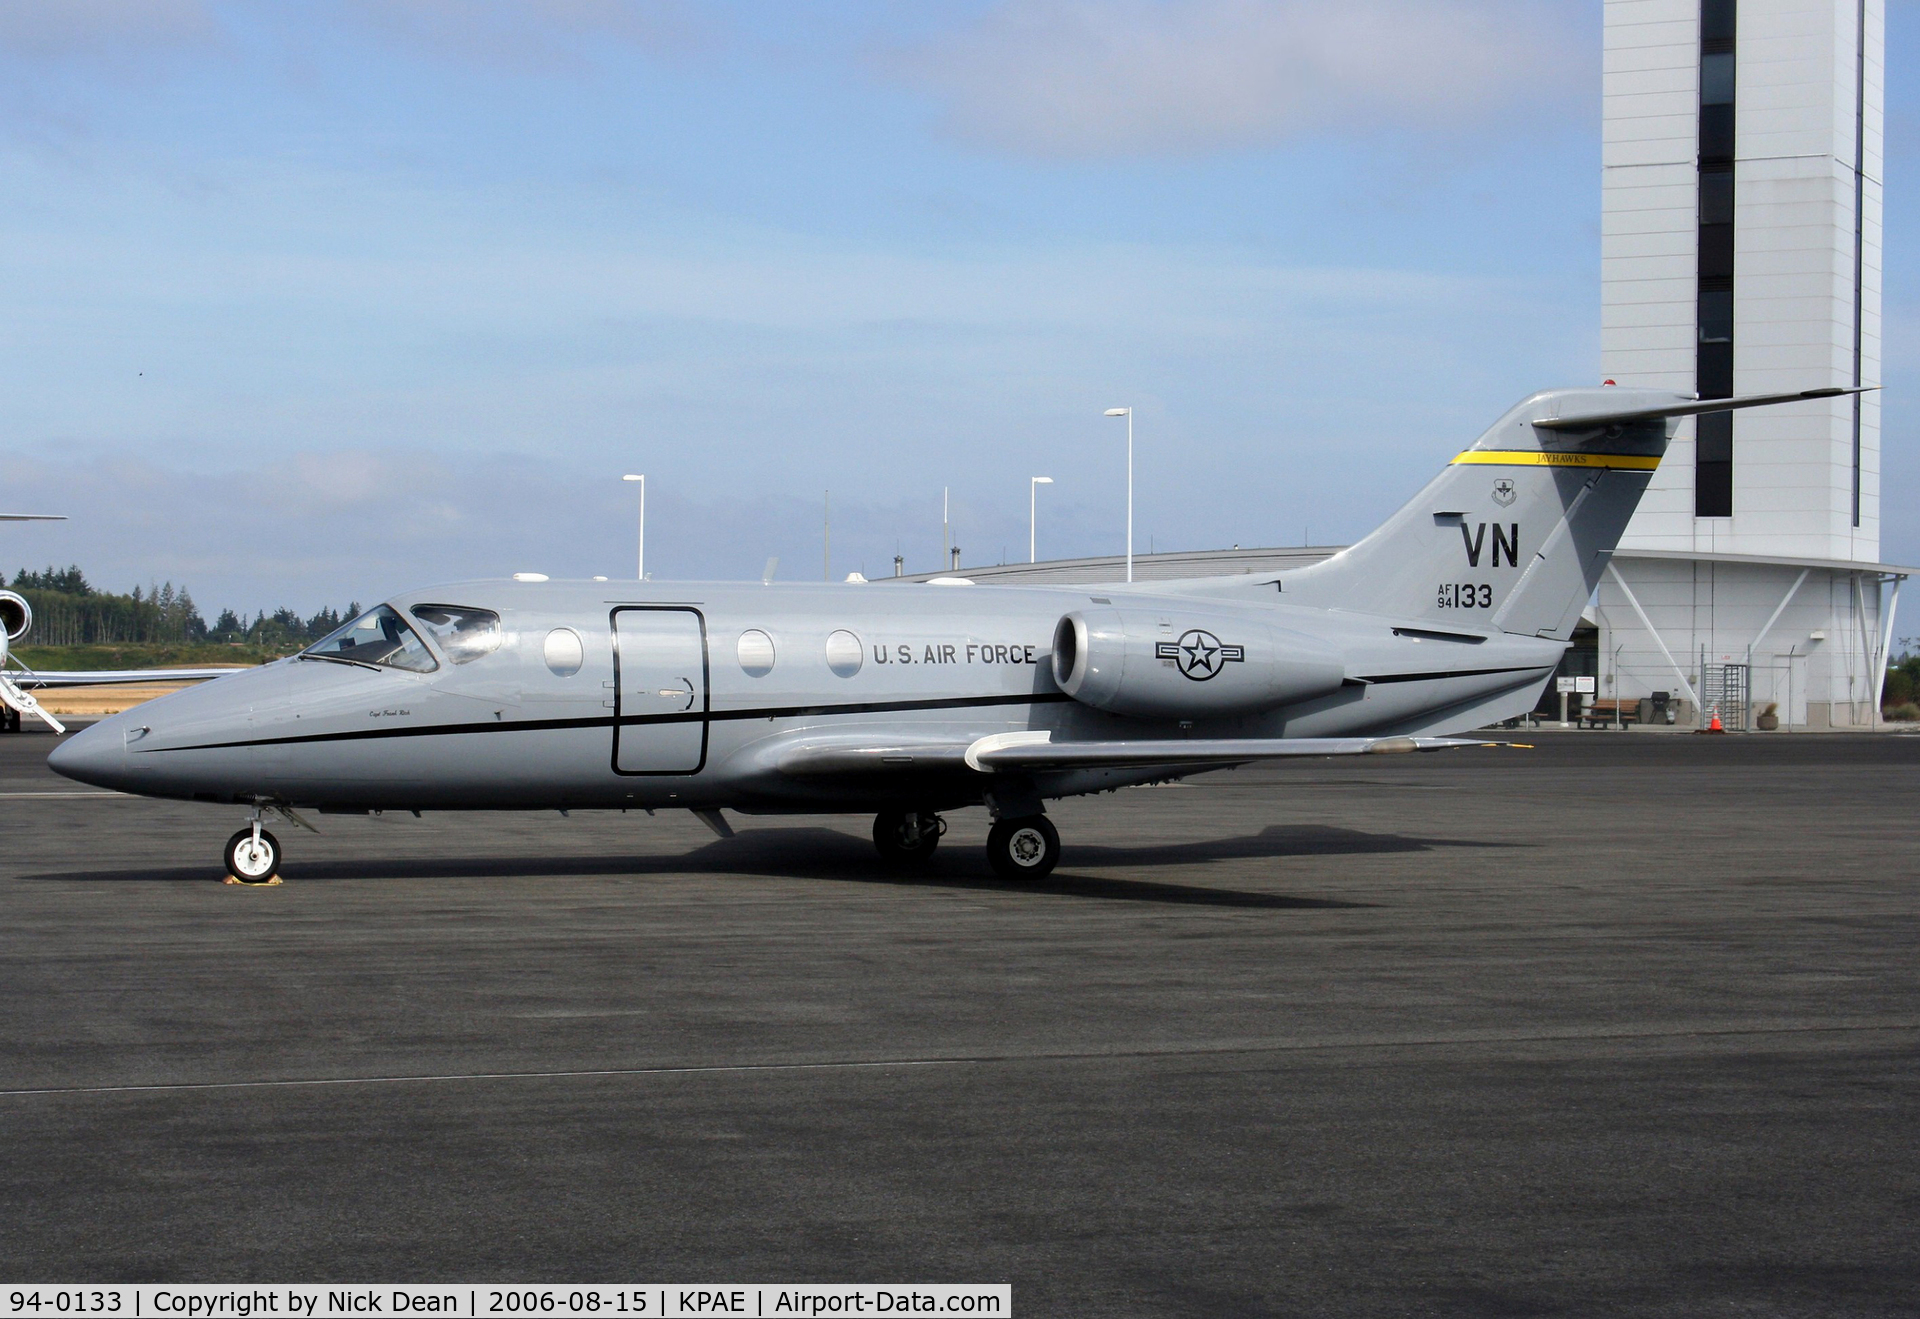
12, 564, 361, 651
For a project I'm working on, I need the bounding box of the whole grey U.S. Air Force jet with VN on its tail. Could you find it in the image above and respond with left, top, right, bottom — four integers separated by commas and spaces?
48, 388, 1853, 883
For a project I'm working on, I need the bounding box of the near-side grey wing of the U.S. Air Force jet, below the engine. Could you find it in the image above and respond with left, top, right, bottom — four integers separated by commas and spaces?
778, 731, 1498, 778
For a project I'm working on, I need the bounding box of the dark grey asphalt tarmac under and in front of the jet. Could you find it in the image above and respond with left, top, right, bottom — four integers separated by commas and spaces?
0, 733, 1920, 1315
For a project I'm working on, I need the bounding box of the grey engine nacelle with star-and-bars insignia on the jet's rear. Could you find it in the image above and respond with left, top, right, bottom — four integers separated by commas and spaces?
1054, 605, 1346, 718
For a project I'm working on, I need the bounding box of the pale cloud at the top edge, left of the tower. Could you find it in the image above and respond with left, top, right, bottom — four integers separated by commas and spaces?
895, 0, 1594, 157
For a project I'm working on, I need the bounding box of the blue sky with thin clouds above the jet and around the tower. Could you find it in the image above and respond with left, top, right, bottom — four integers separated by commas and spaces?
0, 0, 1920, 612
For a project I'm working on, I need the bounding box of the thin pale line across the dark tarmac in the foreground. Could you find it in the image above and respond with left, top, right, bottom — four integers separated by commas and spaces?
0, 1018, 1920, 1098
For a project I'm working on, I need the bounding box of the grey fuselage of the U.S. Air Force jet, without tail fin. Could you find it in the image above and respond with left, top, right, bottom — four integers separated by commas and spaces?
60, 582, 1565, 812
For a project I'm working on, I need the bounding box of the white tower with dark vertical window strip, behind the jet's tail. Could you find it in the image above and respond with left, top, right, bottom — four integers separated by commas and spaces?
1596, 0, 1903, 728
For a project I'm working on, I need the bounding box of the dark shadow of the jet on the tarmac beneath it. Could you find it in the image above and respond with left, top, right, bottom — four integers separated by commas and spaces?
11, 824, 1521, 908
